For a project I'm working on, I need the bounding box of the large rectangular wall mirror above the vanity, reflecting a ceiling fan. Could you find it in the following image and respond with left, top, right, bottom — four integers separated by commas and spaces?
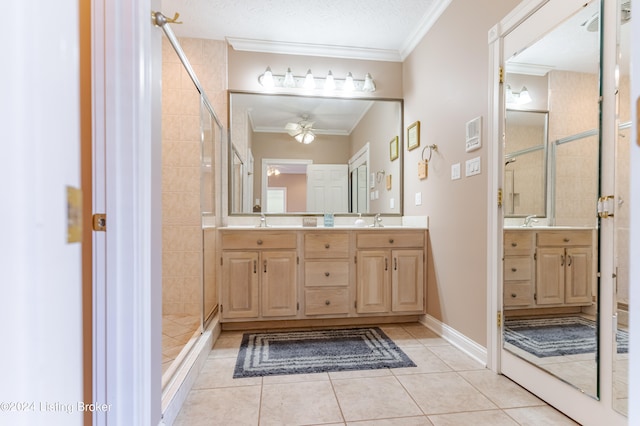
228, 92, 403, 215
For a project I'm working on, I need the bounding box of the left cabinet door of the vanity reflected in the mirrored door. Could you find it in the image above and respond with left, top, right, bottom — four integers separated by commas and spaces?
536, 247, 566, 305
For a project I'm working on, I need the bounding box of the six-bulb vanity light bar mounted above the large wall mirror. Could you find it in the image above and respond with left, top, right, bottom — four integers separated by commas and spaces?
258, 67, 376, 94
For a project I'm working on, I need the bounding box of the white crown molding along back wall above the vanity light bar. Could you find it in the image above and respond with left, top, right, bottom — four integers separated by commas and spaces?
227, 37, 402, 62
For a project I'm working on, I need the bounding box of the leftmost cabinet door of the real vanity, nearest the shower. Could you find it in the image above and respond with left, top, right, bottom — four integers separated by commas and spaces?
222, 252, 259, 318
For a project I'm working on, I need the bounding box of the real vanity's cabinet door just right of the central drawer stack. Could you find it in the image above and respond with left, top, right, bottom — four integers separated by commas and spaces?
356, 250, 391, 314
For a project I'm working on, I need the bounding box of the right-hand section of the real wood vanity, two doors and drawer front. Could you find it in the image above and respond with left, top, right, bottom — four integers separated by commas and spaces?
356, 231, 425, 314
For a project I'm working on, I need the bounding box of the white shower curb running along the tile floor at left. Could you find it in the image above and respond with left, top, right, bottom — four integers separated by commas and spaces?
161, 315, 222, 425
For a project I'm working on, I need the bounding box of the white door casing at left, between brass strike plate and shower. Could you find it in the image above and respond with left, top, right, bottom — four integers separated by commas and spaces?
91, 0, 162, 425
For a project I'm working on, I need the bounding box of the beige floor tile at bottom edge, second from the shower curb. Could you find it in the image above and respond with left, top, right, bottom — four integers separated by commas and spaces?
260, 381, 343, 426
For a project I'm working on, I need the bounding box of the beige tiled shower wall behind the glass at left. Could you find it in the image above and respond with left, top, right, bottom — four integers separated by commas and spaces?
162, 38, 227, 315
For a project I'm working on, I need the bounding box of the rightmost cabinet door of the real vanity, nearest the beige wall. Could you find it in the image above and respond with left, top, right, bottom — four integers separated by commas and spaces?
391, 250, 424, 312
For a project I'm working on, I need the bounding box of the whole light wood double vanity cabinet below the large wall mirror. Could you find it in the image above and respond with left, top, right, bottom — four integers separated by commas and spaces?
218, 227, 427, 328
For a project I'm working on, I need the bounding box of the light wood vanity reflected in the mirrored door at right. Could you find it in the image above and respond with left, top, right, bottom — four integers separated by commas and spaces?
503, 227, 596, 310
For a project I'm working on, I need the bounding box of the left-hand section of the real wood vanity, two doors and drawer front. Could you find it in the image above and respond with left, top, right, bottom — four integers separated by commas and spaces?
221, 232, 298, 320
